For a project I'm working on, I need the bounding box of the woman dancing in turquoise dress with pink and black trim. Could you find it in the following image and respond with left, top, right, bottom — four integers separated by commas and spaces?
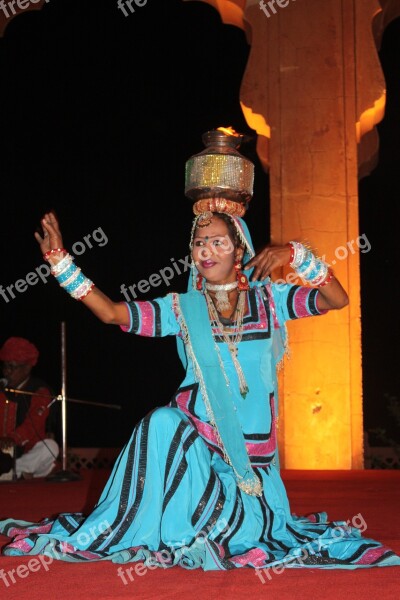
0, 203, 400, 570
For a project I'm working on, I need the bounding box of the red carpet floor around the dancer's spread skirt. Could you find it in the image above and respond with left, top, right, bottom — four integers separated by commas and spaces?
0, 470, 400, 600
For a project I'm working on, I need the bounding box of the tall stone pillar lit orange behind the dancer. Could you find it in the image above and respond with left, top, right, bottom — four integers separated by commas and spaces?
188, 0, 400, 469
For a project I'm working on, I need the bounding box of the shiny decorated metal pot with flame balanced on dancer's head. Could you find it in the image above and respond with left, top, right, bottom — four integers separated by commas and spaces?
185, 127, 254, 209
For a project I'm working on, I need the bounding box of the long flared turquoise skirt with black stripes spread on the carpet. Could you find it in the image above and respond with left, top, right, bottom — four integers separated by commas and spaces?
0, 407, 400, 570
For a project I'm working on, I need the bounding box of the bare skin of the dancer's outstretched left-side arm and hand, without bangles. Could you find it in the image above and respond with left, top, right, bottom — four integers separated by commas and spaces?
35, 212, 130, 327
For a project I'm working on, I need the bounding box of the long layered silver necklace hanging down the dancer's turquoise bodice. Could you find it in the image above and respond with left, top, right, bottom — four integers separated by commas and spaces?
204, 282, 249, 398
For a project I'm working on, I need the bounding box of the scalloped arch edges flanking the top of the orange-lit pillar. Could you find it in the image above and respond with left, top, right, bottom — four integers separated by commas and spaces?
183, 0, 400, 178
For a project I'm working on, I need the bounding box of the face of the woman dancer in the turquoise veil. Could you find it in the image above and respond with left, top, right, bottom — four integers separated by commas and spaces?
192, 217, 242, 284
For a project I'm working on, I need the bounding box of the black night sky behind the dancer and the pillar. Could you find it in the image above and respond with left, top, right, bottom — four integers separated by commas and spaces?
0, 0, 400, 447
